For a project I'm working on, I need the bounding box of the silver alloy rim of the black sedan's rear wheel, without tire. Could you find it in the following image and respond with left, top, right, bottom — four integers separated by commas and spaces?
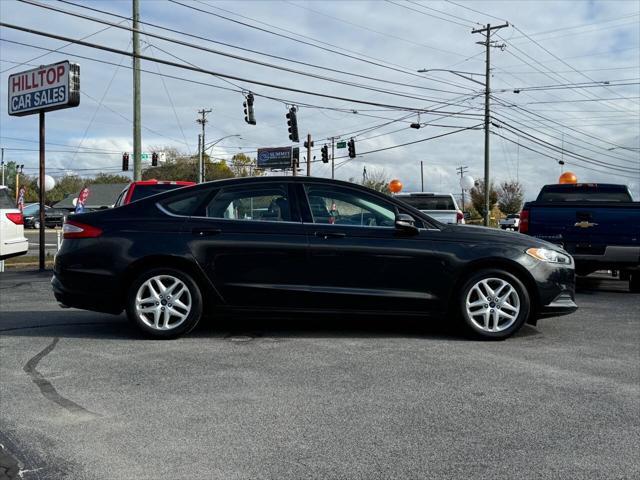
135, 275, 192, 331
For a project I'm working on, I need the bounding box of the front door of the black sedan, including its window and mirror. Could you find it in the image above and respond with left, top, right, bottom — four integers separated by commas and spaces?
300, 182, 443, 313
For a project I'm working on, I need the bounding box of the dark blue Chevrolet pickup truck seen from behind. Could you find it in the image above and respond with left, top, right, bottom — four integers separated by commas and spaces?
520, 183, 640, 292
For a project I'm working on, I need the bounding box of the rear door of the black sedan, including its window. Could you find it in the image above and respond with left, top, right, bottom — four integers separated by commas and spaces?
185, 179, 308, 308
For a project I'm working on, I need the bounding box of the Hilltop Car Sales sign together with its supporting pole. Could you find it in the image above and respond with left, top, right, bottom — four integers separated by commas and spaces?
8, 61, 80, 270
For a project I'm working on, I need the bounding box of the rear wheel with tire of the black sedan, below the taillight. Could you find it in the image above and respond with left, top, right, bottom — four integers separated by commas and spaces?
126, 268, 202, 339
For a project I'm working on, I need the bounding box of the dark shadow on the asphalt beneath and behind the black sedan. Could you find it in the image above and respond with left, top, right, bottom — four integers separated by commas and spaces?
0, 309, 540, 341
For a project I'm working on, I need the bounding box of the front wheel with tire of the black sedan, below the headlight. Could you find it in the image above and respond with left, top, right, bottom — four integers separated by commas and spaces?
456, 269, 531, 340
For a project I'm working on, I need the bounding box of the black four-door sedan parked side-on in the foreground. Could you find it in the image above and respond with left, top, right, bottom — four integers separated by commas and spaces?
52, 177, 577, 339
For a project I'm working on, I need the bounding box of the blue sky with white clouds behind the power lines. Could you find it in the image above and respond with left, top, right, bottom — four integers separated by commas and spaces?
0, 0, 640, 200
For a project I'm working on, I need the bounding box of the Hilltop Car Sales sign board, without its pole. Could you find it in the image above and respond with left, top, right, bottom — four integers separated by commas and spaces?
9, 61, 80, 116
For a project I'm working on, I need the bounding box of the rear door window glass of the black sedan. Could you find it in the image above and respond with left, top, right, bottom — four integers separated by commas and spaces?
206, 184, 292, 222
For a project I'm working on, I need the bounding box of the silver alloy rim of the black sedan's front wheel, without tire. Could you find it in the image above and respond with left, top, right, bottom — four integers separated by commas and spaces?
465, 277, 520, 332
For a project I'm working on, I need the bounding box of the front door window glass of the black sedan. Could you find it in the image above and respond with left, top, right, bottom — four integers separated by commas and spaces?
305, 185, 395, 227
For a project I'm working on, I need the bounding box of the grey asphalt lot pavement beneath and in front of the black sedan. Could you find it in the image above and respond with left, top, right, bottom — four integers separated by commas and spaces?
0, 272, 640, 480
